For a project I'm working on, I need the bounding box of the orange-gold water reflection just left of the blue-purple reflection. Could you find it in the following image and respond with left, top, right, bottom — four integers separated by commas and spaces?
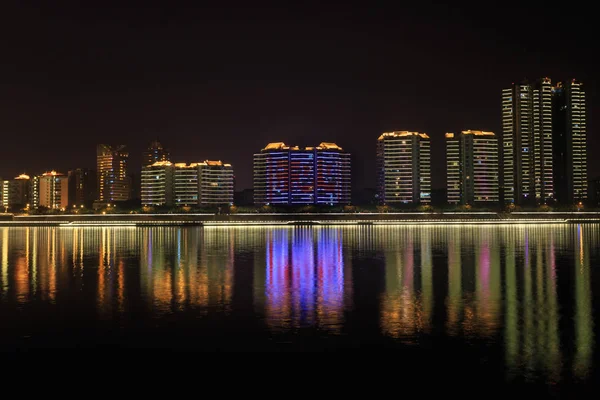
140, 228, 234, 315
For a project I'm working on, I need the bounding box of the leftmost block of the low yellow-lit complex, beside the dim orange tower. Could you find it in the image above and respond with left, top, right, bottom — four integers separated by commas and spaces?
141, 161, 174, 206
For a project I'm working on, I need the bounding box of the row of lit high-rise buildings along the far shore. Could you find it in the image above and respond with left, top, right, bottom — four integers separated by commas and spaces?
0, 70, 597, 209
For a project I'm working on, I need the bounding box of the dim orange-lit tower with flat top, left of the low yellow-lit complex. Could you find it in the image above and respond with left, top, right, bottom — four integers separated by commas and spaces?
97, 144, 130, 203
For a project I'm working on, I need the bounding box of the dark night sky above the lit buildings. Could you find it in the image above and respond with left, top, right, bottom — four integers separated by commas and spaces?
0, 0, 600, 189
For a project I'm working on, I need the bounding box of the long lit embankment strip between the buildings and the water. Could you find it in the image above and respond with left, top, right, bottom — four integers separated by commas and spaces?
0, 211, 600, 227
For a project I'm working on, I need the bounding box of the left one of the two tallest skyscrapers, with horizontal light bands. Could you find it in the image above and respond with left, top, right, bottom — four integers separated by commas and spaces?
502, 78, 554, 204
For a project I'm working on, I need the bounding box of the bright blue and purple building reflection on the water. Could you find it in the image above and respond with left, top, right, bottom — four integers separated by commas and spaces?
254, 228, 352, 332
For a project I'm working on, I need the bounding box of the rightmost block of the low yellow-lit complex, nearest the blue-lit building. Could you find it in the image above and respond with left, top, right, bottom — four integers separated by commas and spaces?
198, 160, 234, 206
